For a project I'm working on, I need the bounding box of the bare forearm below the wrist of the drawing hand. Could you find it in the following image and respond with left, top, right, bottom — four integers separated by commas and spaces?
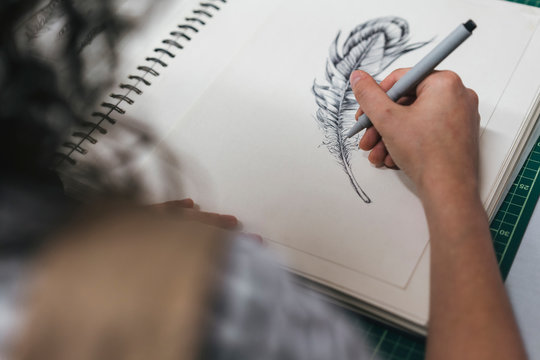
424, 186, 526, 359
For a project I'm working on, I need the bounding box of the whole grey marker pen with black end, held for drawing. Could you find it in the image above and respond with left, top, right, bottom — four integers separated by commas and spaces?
347, 20, 476, 138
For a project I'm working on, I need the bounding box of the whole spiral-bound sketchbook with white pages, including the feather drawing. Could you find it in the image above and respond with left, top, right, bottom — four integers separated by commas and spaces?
53, 0, 540, 334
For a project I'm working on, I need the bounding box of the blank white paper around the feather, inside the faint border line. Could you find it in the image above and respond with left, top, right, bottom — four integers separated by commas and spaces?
139, 1, 540, 287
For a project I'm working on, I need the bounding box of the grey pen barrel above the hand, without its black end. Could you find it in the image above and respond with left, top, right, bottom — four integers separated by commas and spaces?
386, 24, 472, 101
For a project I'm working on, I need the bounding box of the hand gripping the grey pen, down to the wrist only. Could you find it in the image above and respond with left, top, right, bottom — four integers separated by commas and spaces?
351, 69, 480, 201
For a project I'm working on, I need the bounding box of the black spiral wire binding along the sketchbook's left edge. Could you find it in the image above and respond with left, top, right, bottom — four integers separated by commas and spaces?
57, 0, 227, 165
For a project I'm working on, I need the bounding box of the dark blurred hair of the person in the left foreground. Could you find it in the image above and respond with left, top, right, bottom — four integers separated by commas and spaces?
0, 0, 169, 250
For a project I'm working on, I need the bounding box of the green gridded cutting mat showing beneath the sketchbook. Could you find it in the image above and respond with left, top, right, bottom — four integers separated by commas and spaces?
350, 0, 540, 354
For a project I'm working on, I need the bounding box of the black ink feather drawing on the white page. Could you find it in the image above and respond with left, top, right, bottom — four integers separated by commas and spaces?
312, 17, 428, 203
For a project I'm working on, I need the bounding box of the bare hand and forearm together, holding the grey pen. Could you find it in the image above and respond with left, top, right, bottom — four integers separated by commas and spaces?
351, 69, 525, 360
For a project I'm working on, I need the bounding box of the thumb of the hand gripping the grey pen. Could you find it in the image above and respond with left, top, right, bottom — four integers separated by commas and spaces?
350, 70, 399, 135
